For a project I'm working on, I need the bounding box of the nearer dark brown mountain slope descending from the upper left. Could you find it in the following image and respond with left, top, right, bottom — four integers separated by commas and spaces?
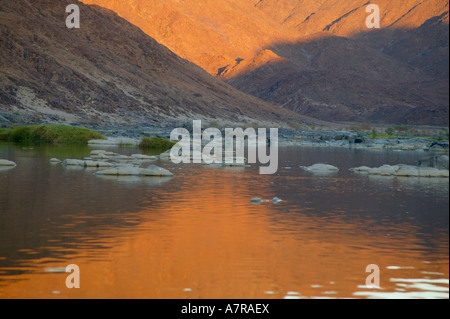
0, 0, 317, 125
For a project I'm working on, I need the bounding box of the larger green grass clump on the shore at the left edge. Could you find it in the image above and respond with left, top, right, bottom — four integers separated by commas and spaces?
0, 124, 106, 144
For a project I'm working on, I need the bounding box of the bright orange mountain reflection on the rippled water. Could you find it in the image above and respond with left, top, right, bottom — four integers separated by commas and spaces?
0, 169, 448, 299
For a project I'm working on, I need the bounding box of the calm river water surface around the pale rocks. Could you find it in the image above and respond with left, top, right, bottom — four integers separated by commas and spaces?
0, 144, 449, 298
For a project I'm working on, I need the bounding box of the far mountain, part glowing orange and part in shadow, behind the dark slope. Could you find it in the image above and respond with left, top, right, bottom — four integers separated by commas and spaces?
84, 0, 449, 125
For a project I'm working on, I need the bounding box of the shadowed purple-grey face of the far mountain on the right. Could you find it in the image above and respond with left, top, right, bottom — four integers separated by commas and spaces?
222, 7, 449, 125
